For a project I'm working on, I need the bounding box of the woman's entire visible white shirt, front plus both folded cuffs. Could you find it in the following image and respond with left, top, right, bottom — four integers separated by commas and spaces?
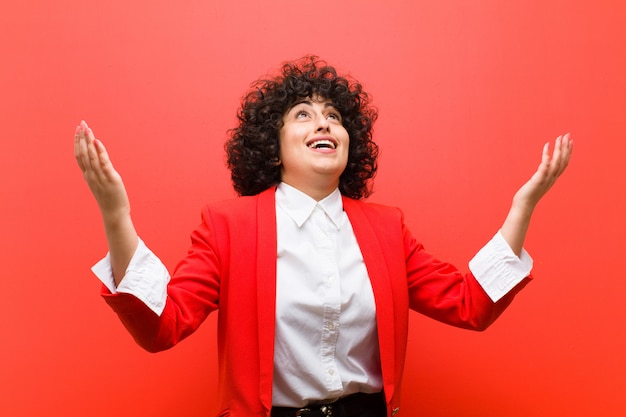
92, 183, 532, 407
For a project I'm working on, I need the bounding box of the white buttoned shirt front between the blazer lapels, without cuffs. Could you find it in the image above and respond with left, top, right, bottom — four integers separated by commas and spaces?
272, 183, 382, 407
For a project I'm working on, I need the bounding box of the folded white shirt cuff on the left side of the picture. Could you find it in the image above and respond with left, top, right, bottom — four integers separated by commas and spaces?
91, 239, 170, 316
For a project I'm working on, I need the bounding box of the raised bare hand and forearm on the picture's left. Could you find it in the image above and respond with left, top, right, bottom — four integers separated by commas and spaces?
74, 121, 139, 285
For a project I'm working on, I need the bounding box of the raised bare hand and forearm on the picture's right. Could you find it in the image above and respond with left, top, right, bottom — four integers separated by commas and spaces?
501, 133, 573, 256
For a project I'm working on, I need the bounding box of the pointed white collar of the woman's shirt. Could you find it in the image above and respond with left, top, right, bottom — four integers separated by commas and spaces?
276, 182, 343, 230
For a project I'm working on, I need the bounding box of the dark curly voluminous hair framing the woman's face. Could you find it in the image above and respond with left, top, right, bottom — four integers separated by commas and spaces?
224, 56, 378, 199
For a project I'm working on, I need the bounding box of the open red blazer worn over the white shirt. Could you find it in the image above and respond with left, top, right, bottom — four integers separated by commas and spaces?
104, 187, 528, 417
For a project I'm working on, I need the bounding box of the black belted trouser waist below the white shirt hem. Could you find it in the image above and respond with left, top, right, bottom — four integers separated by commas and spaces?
270, 392, 387, 417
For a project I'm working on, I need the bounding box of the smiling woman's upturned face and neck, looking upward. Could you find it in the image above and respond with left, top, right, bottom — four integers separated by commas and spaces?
279, 97, 350, 197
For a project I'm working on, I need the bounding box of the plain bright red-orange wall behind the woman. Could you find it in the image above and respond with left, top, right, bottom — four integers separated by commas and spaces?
0, 0, 626, 417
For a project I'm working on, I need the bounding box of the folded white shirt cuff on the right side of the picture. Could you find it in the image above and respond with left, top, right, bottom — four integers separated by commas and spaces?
469, 231, 533, 303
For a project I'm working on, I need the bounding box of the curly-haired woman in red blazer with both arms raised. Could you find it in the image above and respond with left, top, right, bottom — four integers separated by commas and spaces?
74, 57, 572, 417
